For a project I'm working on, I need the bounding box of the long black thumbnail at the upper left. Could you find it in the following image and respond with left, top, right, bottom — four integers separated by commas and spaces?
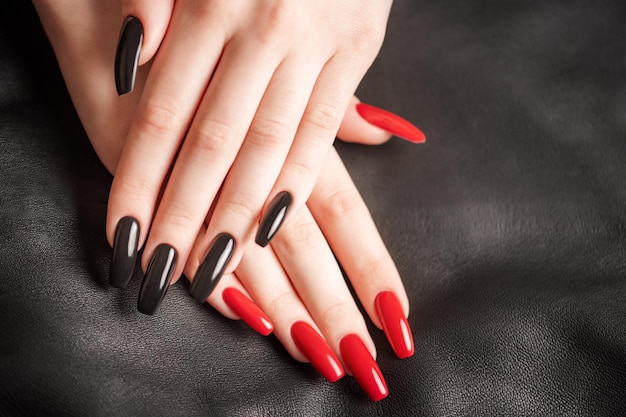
115, 16, 143, 96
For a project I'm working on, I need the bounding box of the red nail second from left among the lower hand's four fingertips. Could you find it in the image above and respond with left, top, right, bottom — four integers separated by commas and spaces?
291, 321, 345, 382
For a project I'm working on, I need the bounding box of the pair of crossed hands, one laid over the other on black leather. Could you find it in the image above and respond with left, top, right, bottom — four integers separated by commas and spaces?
35, 0, 413, 400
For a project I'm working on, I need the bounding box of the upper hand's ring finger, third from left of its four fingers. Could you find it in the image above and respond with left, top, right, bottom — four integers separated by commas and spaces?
185, 55, 321, 300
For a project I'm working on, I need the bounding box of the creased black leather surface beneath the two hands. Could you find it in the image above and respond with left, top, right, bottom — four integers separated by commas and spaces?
0, 0, 626, 417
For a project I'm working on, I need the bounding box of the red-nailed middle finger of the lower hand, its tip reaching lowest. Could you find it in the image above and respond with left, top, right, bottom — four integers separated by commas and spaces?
272, 207, 388, 401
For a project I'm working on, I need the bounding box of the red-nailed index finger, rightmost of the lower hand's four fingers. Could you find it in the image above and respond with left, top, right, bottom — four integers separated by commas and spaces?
308, 149, 414, 358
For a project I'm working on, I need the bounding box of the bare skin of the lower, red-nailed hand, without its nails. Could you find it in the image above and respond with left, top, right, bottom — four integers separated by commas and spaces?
34, 0, 408, 370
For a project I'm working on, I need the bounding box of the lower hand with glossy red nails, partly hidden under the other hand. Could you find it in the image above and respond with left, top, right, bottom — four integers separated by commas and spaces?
36, 0, 420, 399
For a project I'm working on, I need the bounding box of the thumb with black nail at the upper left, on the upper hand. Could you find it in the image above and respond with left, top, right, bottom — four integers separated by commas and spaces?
115, 0, 174, 96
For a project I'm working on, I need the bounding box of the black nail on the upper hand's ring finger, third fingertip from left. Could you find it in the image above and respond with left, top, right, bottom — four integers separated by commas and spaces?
189, 233, 236, 302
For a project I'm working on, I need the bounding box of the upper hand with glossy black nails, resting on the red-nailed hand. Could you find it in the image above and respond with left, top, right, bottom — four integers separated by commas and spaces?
107, 0, 391, 300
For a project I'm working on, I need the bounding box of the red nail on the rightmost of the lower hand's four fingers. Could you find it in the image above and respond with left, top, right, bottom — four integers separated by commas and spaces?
374, 291, 415, 359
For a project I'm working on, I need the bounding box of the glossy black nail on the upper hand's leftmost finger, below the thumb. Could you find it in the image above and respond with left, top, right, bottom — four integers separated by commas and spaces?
109, 216, 139, 288
